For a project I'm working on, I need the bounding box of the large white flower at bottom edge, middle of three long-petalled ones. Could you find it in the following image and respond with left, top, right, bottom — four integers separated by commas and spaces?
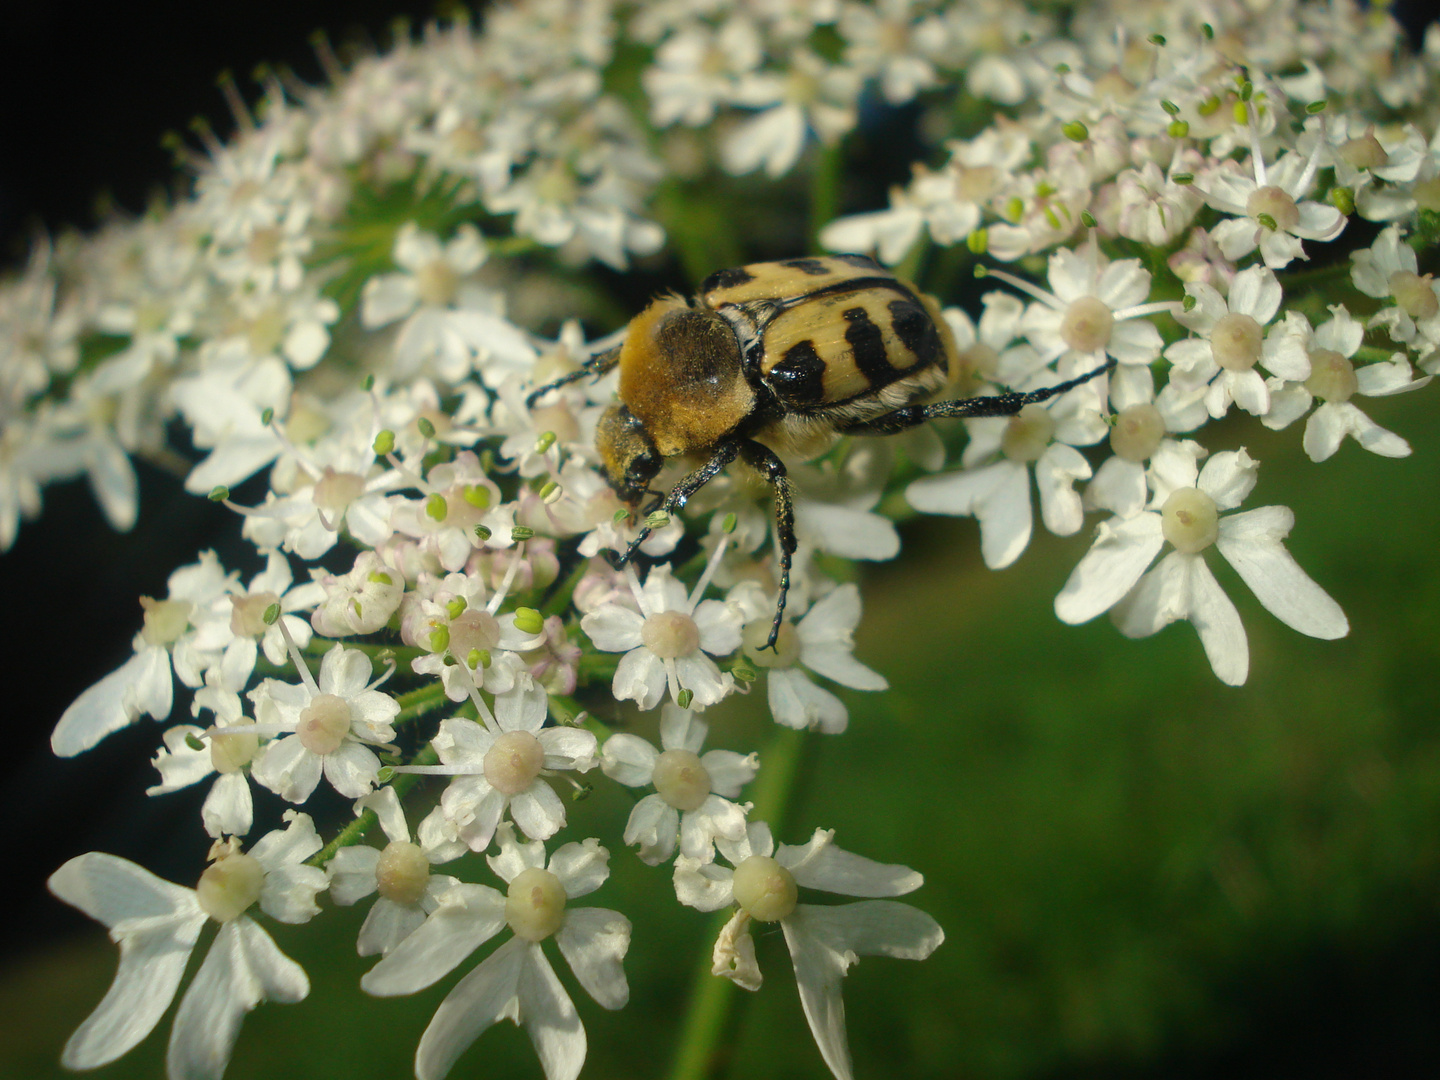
360, 825, 631, 1080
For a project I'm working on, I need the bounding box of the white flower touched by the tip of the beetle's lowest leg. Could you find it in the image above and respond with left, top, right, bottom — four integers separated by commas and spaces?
731, 582, 890, 737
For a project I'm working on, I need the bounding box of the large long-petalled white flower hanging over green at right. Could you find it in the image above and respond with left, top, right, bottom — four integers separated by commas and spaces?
1056, 449, 1349, 685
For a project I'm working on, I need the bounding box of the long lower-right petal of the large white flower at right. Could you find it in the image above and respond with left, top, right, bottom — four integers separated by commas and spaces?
1215, 507, 1349, 641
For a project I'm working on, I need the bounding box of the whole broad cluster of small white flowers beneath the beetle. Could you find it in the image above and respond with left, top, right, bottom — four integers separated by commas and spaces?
19, 0, 1440, 1080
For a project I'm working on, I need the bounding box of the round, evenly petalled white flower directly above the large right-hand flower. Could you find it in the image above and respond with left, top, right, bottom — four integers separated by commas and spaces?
1165, 266, 1310, 419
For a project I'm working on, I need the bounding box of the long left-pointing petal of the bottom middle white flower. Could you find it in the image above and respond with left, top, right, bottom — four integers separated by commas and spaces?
360, 884, 505, 996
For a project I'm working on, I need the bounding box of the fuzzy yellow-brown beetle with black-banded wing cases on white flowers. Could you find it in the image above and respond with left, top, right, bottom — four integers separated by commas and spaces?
527, 255, 1115, 649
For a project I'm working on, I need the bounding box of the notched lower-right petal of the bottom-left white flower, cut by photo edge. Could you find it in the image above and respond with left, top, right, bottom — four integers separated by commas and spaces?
166, 916, 310, 1080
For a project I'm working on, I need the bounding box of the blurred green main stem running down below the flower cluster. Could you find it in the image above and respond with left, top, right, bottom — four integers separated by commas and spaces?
670, 727, 815, 1080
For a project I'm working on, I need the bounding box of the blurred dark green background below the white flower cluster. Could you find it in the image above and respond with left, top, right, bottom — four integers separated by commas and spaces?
0, 365, 1440, 1080
